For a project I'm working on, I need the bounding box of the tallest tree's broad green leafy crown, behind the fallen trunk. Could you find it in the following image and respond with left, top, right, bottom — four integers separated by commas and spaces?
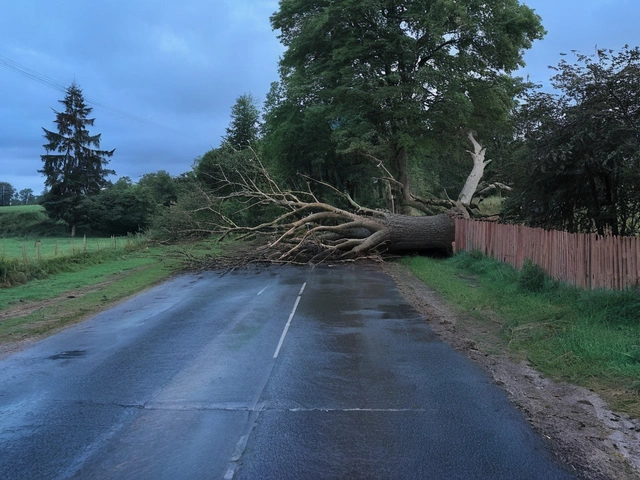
265, 0, 544, 207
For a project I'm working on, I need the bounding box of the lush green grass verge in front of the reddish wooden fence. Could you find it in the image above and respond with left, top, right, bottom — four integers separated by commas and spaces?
405, 253, 640, 418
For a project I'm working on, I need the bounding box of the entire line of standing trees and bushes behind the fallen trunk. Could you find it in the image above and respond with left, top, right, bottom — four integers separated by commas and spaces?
22, 0, 640, 248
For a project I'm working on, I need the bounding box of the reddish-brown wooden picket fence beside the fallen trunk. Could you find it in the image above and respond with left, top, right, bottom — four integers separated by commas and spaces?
454, 219, 640, 290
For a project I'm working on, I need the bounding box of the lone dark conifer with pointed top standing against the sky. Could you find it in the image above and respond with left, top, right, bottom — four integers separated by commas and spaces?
38, 83, 115, 233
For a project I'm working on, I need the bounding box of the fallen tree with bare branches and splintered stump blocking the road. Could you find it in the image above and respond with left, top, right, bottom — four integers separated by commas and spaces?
178, 134, 498, 263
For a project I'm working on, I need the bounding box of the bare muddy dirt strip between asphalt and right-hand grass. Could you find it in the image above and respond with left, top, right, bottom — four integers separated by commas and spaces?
385, 263, 640, 480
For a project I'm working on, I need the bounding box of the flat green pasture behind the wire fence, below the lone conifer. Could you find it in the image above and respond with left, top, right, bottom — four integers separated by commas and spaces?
0, 235, 142, 262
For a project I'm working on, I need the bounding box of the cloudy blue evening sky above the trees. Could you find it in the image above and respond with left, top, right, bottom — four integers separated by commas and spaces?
0, 0, 640, 194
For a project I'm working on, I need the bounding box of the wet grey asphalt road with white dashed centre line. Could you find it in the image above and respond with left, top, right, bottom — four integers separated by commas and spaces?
0, 266, 572, 480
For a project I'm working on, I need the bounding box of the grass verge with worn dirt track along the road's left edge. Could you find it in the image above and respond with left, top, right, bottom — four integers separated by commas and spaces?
0, 241, 223, 352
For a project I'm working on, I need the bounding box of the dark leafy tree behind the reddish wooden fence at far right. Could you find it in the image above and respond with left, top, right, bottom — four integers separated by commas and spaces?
505, 47, 640, 235
